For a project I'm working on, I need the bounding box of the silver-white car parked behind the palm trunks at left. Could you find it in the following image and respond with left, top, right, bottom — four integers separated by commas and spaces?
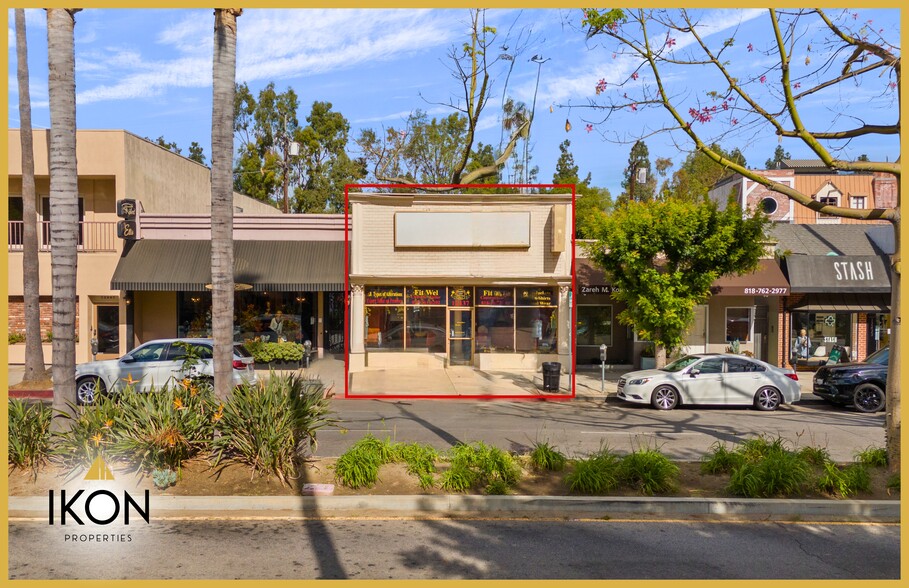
76, 339, 258, 404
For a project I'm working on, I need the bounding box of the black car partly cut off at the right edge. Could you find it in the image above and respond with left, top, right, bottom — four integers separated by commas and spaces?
814, 347, 890, 412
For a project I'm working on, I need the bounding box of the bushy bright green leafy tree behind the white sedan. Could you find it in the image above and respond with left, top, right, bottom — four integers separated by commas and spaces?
588, 198, 767, 367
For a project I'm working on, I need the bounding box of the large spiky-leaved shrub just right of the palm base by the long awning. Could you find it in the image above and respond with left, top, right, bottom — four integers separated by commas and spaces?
211, 374, 335, 484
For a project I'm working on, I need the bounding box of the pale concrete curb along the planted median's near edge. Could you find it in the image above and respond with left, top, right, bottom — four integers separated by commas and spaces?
8, 495, 900, 521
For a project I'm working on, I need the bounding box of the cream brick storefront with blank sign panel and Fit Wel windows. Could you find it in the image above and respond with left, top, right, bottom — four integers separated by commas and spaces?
349, 193, 572, 372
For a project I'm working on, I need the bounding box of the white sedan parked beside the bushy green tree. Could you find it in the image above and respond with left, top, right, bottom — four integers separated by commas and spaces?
618, 353, 801, 410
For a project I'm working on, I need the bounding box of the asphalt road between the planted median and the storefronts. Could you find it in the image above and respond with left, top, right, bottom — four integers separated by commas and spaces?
316, 397, 884, 461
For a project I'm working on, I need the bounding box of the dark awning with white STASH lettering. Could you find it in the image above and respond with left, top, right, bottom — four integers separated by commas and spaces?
786, 255, 890, 294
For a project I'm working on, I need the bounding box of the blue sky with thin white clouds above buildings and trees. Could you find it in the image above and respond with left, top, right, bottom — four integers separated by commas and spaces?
7, 9, 899, 197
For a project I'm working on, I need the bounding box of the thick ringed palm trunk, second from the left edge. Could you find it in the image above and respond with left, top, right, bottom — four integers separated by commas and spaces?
47, 8, 79, 428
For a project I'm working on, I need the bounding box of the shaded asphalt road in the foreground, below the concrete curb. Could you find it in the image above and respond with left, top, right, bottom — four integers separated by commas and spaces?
9, 519, 900, 579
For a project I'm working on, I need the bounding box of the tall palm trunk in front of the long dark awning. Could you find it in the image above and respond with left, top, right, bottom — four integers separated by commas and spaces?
211, 8, 243, 401
